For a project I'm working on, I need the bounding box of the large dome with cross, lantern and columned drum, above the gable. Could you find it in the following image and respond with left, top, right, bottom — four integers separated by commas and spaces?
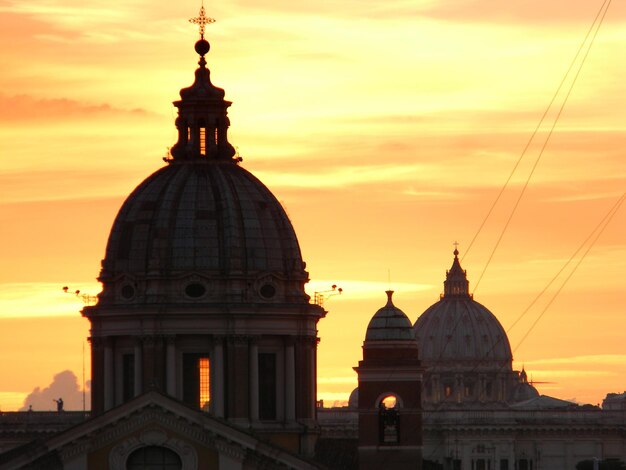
83, 8, 326, 455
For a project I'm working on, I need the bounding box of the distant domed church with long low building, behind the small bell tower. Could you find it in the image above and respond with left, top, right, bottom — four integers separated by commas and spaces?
318, 250, 626, 470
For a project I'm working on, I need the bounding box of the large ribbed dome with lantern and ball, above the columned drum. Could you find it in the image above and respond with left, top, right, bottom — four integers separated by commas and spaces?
99, 30, 309, 304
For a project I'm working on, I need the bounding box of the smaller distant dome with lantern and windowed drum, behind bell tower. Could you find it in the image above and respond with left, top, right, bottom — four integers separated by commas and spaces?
414, 250, 520, 407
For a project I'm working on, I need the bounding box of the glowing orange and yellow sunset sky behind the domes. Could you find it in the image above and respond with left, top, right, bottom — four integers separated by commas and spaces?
0, 0, 626, 411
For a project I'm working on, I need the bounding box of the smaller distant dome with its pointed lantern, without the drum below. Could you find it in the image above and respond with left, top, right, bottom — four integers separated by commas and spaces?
415, 250, 513, 370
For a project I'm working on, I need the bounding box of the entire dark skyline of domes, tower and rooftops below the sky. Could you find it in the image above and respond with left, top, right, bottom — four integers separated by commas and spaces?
0, 9, 626, 470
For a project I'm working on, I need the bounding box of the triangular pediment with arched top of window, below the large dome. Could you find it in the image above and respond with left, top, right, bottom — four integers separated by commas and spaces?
0, 392, 320, 470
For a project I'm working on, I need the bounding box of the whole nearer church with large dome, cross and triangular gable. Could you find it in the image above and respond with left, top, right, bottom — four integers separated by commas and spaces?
0, 8, 326, 470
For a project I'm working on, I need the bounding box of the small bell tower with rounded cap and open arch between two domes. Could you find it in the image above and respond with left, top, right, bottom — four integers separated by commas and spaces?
354, 291, 422, 470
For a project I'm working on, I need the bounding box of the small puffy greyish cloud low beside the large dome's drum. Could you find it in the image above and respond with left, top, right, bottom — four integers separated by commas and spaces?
20, 370, 91, 411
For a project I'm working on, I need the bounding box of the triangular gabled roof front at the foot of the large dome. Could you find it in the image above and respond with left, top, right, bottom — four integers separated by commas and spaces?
0, 391, 325, 470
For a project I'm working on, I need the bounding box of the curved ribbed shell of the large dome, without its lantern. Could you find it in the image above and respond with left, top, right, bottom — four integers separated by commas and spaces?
100, 161, 308, 300
